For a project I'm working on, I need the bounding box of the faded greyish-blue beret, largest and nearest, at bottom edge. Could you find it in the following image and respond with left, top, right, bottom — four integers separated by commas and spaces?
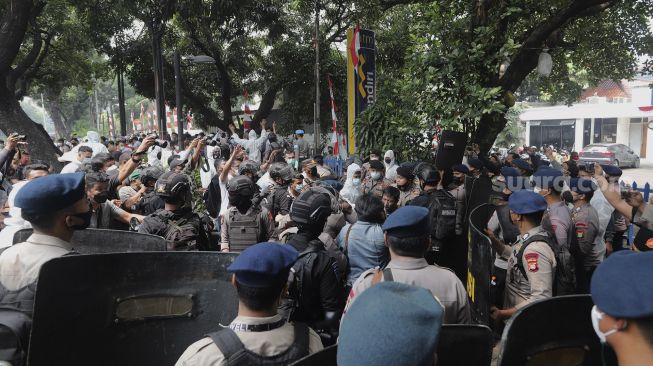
338, 282, 444, 366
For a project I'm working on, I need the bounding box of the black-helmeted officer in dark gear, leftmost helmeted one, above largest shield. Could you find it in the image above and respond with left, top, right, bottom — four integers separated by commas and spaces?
138, 172, 211, 250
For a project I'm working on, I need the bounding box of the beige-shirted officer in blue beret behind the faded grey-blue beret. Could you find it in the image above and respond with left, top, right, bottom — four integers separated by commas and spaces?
345, 206, 471, 324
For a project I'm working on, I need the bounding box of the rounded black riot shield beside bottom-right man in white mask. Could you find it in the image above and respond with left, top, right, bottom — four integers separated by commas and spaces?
497, 295, 617, 366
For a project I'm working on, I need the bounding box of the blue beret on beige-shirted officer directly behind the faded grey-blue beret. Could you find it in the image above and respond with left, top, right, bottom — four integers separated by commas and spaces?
382, 206, 431, 238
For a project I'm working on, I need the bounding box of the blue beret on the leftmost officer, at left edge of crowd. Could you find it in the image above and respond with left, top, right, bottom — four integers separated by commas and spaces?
14, 172, 86, 214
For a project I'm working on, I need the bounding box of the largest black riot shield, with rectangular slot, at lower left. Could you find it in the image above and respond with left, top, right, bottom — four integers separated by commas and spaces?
28, 252, 238, 366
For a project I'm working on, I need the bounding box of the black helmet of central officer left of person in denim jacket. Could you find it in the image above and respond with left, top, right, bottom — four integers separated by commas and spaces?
290, 188, 332, 230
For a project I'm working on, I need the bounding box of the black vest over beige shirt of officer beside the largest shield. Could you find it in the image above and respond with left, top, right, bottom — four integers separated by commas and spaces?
208, 323, 309, 366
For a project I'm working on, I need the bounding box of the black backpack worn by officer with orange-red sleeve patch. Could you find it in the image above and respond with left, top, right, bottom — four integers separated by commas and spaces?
517, 234, 576, 296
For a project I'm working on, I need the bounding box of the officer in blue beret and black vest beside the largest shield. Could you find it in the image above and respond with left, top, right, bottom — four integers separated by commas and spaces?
176, 243, 323, 366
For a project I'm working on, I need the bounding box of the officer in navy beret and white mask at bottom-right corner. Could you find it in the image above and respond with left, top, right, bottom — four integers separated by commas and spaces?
591, 251, 653, 366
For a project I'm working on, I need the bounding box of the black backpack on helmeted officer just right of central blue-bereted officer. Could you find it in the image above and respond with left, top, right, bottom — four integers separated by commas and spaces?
428, 189, 457, 241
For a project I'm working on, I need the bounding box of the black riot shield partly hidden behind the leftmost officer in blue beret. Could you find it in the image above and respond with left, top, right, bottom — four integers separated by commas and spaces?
14, 229, 167, 254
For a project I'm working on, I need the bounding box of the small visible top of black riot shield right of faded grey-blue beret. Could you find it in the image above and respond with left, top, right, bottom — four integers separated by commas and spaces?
438, 324, 493, 366
